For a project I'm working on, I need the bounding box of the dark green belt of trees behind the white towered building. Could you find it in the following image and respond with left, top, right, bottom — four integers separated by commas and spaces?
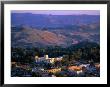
12, 42, 100, 65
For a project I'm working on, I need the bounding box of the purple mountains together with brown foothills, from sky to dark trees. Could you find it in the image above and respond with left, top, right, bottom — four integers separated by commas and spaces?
11, 13, 100, 47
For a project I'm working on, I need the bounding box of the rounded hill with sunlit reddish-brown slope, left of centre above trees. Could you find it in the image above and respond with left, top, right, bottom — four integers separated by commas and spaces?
12, 28, 66, 47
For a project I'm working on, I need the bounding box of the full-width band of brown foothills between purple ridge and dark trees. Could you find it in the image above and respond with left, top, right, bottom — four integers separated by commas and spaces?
11, 27, 99, 47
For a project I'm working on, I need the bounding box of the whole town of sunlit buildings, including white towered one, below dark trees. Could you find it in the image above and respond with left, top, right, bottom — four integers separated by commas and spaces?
11, 54, 100, 77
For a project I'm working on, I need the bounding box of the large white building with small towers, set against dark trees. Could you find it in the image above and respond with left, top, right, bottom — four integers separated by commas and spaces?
35, 55, 63, 63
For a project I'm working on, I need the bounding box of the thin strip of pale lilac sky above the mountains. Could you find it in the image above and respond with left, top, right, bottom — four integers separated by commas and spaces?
12, 10, 100, 15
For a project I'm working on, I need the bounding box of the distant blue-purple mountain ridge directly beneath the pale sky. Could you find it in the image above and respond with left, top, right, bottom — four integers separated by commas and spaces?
11, 13, 100, 28
